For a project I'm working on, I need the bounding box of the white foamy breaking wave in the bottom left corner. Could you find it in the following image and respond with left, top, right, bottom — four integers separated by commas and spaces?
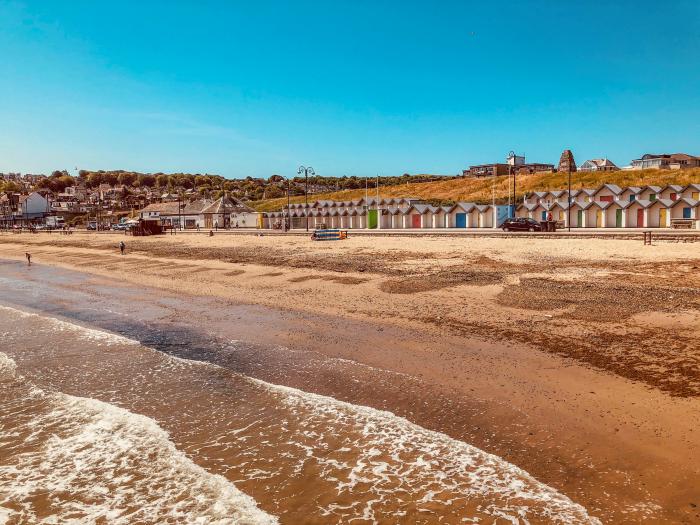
0, 353, 277, 525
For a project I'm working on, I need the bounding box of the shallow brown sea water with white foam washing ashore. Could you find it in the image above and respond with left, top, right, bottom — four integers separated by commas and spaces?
0, 306, 598, 524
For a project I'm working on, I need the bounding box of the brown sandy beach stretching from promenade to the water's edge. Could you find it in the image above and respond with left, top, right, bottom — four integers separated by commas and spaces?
0, 234, 700, 523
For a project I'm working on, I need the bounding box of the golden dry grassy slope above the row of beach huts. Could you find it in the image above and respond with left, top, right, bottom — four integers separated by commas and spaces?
249, 169, 700, 211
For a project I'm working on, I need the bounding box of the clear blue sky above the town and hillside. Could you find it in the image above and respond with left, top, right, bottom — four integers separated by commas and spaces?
0, 0, 700, 177
